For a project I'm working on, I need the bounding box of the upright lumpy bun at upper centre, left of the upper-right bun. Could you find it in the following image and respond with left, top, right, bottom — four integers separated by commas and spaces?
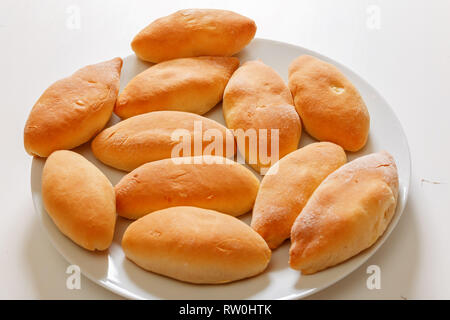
223, 61, 302, 173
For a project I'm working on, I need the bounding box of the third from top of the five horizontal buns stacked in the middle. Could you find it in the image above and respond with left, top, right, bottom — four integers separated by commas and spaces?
92, 111, 235, 171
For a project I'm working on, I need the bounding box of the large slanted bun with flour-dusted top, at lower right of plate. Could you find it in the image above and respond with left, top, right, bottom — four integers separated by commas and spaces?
289, 152, 398, 274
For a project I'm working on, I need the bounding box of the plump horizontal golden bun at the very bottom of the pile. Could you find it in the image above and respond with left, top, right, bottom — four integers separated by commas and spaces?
122, 207, 271, 284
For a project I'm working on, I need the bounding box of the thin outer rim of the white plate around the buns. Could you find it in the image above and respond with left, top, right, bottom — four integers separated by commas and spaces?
30, 37, 412, 300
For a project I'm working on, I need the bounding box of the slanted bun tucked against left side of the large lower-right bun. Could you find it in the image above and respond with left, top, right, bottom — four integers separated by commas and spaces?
251, 142, 347, 249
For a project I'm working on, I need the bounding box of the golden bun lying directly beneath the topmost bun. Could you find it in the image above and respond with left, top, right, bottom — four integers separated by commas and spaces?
114, 57, 239, 118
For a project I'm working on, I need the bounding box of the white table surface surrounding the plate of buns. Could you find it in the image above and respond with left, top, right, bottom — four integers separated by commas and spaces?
0, 0, 450, 299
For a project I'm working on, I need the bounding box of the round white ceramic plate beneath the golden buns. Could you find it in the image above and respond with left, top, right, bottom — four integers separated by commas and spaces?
31, 39, 411, 300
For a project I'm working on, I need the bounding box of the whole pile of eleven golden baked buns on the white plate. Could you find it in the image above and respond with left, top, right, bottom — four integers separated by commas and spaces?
24, 9, 399, 284
